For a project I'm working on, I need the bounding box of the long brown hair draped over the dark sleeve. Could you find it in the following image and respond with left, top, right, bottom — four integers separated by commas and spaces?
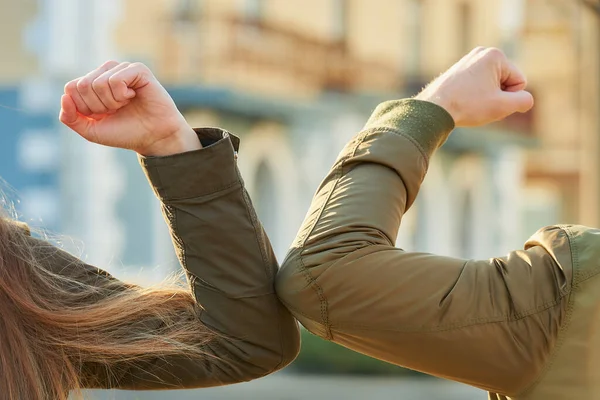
0, 218, 213, 400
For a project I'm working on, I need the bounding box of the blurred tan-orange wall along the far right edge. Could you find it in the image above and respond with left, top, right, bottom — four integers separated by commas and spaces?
518, 0, 600, 226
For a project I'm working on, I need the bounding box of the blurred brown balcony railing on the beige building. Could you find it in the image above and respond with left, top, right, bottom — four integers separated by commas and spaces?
162, 17, 401, 97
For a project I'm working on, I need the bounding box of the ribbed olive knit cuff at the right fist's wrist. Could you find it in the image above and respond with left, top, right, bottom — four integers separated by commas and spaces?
365, 99, 455, 160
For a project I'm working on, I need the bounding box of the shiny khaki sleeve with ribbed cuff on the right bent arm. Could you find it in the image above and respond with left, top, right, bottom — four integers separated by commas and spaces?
276, 100, 571, 395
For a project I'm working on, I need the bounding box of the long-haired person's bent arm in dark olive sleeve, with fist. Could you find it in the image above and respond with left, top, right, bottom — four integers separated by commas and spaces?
60, 62, 299, 389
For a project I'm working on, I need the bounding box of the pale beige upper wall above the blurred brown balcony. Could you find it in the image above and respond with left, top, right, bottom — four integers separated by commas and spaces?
116, 0, 501, 86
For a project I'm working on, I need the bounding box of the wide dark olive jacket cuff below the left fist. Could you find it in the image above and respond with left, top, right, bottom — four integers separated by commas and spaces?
138, 128, 240, 202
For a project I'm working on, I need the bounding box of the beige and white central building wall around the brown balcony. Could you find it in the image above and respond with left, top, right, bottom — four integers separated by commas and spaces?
110, 0, 523, 258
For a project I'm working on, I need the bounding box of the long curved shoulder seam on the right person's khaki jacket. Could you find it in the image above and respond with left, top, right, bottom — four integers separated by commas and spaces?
517, 226, 579, 397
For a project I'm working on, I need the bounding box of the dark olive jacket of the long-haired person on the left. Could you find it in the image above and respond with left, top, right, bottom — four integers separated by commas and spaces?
18, 129, 300, 390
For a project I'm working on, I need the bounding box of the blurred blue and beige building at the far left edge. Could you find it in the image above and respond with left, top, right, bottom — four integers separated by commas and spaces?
0, 0, 60, 231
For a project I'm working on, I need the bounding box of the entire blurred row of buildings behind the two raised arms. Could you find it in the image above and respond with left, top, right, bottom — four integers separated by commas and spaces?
0, 0, 600, 280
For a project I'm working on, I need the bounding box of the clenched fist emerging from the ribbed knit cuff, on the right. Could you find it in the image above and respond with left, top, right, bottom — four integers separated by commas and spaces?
415, 47, 533, 127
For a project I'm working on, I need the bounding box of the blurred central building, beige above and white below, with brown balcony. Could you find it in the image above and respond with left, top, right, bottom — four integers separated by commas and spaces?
117, 0, 532, 257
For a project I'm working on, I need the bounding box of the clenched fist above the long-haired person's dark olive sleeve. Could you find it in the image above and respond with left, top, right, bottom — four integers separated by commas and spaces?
60, 61, 201, 156
